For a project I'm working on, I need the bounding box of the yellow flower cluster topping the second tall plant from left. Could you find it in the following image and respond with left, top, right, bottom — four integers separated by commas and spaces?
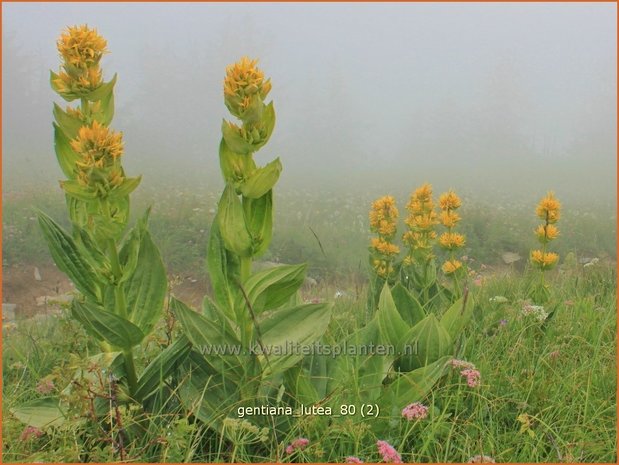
224, 57, 271, 119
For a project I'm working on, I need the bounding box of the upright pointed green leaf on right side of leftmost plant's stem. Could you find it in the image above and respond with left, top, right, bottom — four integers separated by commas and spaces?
124, 231, 168, 334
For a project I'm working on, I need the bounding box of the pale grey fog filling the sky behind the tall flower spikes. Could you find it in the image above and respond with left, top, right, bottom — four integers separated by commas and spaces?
2, 3, 617, 208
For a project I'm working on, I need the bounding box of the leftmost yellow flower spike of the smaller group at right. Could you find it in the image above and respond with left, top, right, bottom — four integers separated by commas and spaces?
370, 195, 400, 278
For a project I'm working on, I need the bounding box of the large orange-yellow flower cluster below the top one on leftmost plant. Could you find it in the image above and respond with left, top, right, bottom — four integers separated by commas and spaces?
71, 121, 124, 187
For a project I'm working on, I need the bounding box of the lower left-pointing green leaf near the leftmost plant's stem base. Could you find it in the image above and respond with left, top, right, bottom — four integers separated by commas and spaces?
71, 300, 144, 349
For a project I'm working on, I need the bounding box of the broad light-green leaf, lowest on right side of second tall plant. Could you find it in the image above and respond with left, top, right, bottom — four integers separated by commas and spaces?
260, 304, 331, 376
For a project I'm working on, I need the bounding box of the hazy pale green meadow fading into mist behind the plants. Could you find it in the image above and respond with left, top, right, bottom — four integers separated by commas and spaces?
2, 185, 617, 281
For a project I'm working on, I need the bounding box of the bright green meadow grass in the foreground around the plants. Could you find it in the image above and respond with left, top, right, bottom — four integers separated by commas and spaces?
2, 262, 617, 462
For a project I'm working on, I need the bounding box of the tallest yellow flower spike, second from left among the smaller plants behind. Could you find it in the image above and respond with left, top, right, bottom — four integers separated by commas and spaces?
402, 183, 438, 263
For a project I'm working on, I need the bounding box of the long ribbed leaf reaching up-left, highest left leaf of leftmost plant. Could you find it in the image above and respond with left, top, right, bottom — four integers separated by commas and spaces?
37, 212, 102, 302
